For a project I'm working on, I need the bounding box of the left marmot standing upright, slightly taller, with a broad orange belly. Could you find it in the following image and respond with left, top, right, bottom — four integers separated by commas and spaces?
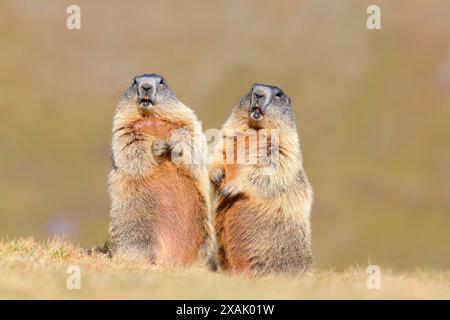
108, 74, 214, 266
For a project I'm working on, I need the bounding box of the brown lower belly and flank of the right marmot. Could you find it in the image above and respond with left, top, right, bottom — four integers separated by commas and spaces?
216, 199, 304, 273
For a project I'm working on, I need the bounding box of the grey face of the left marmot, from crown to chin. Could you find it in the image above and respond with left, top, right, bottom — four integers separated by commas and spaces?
121, 74, 178, 111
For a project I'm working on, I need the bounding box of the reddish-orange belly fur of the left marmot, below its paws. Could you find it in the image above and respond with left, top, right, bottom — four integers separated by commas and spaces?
147, 164, 207, 265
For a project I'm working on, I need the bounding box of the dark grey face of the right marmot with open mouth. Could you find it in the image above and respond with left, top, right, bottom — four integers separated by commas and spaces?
239, 83, 295, 128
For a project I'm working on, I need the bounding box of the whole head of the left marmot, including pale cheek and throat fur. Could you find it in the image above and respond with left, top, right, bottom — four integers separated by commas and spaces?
118, 74, 184, 116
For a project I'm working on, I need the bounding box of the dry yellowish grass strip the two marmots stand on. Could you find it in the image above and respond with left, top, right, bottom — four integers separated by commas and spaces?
0, 238, 450, 299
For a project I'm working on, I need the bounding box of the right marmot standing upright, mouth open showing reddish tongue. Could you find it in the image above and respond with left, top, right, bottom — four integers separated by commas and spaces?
210, 84, 314, 275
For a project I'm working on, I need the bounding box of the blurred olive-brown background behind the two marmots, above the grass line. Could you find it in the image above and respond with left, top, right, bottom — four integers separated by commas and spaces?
0, 0, 450, 270
